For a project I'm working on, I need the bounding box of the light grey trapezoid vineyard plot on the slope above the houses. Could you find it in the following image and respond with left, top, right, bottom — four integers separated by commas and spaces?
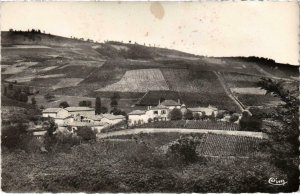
97, 69, 169, 92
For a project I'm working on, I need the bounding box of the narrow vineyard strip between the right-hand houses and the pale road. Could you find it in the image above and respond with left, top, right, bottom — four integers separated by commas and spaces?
137, 120, 239, 131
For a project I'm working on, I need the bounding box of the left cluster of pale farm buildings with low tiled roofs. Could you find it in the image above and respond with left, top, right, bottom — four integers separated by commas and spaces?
42, 107, 125, 133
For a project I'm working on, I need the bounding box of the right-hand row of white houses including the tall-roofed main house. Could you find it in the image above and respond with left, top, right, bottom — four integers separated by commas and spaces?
128, 100, 218, 126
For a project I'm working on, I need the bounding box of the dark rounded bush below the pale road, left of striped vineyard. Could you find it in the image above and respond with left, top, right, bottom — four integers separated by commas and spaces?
167, 137, 200, 162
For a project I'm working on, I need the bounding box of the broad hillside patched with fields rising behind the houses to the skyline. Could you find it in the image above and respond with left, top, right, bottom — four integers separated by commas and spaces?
1, 32, 298, 110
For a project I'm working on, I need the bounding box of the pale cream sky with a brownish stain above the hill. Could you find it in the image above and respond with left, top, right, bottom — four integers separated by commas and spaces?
1, 1, 299, 65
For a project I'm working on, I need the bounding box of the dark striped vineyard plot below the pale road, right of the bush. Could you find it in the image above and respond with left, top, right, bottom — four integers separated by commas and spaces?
197, 133, 263, 156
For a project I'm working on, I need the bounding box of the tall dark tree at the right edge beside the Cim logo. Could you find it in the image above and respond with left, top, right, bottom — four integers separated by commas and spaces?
258, 78, 300, 192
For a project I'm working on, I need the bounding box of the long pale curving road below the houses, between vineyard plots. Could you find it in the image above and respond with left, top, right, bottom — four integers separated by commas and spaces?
97, 128, 266, 139
